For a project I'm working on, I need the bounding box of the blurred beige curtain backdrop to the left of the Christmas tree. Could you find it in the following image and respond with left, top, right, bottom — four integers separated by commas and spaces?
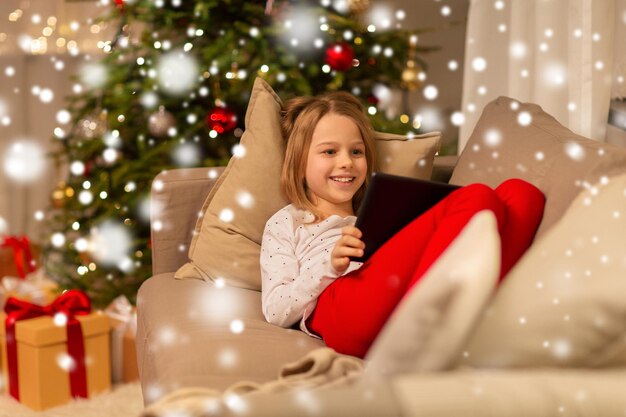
0, 0, 107, 236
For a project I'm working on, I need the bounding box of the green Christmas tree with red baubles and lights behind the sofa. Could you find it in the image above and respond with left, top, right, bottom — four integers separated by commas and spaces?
45, 0, 432, 306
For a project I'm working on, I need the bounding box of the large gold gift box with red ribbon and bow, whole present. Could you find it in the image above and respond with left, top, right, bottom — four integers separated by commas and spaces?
0, 290, 111, 410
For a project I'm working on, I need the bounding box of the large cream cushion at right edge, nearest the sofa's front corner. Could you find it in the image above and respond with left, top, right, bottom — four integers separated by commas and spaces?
462, 174, 626, 367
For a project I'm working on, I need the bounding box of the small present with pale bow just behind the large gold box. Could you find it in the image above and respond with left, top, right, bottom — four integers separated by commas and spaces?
0, 268, 58, 307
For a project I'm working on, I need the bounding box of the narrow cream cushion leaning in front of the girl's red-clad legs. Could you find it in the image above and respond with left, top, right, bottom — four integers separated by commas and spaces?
365, 211, 500, 379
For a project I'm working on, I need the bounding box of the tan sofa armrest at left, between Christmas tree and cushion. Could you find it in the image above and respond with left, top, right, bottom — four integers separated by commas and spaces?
150, 167, 224, 275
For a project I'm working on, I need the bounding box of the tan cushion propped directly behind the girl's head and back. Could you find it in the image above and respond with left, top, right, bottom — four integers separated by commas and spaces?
176, 78, 441, 290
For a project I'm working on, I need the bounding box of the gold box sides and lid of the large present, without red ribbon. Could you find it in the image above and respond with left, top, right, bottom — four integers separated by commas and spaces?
0, 312, 111, 411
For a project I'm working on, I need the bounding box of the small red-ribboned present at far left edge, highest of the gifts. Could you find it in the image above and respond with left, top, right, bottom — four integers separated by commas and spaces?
0, 236, 38, 278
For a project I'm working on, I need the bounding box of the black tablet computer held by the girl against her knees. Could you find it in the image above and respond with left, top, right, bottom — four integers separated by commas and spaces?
351, 172, 460, 262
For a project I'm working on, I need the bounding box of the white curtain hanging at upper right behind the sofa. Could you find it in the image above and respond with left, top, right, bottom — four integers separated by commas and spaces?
459, 0, 626, 153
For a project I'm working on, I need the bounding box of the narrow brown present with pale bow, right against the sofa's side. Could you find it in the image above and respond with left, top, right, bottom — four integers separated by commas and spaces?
104, 295, 139, 383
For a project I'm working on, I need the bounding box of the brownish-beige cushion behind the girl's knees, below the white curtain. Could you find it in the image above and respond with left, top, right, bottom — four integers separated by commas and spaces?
450, 97, 626, 237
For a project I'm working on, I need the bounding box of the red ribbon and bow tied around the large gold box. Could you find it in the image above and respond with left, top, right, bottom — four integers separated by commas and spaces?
4, 290, 91, 401
